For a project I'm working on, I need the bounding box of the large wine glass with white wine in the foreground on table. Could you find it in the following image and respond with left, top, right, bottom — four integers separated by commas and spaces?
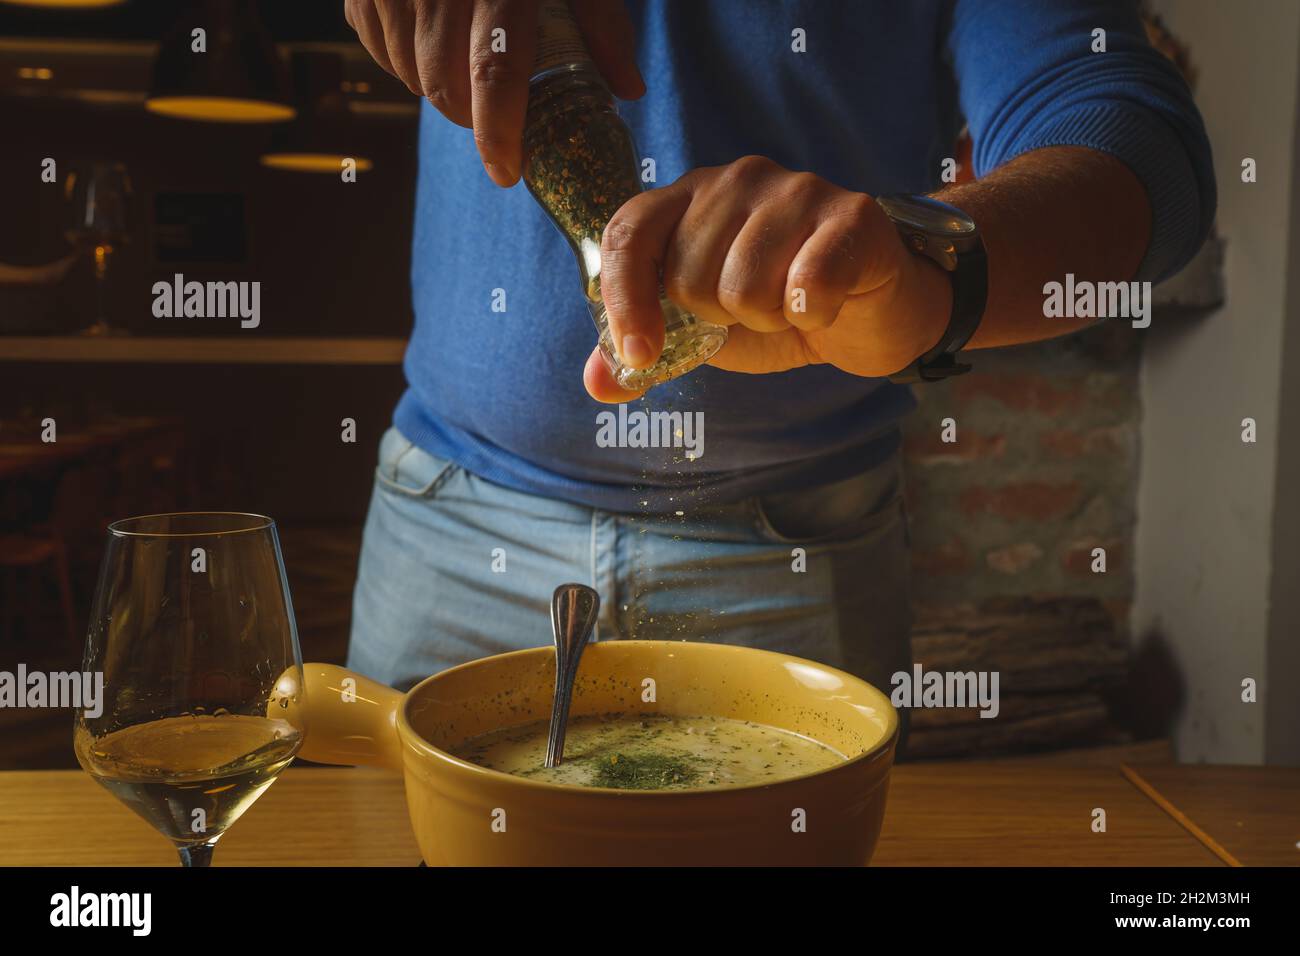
73, 512, 304, 866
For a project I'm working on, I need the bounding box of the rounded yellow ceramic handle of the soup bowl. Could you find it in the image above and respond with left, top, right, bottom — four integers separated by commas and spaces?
281, 663, 406, 771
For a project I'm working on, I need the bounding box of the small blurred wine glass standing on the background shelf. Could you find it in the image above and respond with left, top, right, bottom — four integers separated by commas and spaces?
64, 163, 131, 336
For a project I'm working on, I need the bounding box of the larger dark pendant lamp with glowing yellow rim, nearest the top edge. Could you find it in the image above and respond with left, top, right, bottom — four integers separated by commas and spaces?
144, 0, 294, 122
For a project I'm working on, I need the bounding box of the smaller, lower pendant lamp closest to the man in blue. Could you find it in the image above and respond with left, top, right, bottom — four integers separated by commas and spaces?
261, 51, 373, 176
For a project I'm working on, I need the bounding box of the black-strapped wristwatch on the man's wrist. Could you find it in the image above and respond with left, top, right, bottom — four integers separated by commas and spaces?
876, 195, 988, 384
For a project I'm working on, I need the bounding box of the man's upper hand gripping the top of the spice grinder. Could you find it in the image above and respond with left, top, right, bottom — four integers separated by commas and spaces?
343, 0, 645, 186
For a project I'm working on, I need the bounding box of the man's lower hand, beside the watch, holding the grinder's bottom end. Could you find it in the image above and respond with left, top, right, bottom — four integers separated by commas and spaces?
584, 156, 952, 402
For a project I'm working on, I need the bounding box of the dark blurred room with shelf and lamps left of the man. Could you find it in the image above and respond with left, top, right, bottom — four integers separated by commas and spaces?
0, 0, 419, 769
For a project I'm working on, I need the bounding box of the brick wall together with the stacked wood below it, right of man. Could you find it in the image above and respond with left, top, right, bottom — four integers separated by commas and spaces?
905, 321, 1141, 757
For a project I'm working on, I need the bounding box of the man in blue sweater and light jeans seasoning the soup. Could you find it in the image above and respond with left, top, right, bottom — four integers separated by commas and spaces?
346, 0, 1216, 723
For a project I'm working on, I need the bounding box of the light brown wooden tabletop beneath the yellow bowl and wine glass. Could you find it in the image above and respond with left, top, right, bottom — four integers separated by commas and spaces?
0, 761, 1300, 866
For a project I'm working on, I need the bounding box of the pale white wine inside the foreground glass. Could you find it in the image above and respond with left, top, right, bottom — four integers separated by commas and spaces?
75, 714, 302, 845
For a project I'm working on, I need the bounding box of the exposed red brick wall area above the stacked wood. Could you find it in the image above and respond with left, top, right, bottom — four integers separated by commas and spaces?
905, 323, 1140, 620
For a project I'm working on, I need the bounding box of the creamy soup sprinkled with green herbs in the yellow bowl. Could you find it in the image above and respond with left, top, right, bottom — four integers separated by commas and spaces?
451, 714, 845, 790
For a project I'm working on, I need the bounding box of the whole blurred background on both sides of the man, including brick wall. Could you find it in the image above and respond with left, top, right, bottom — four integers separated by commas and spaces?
0, 0, 1300, 769
